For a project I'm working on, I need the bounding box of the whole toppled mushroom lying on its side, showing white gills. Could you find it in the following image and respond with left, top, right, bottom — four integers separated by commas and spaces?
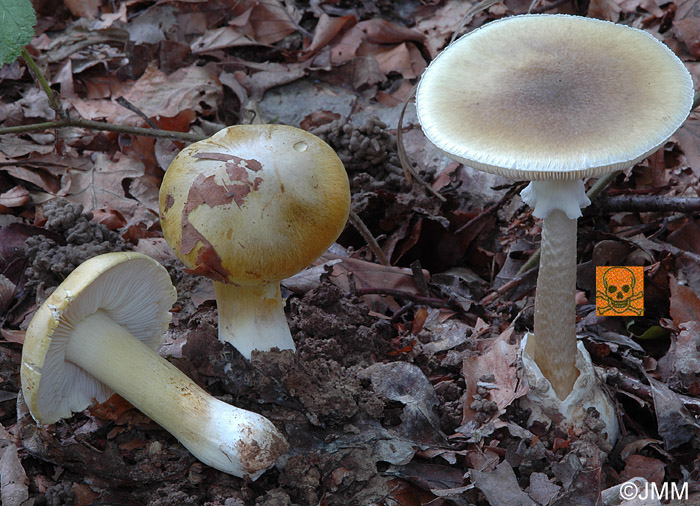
20, 252, 287, 479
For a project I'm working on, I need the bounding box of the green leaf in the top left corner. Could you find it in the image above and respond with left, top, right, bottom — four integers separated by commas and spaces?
0, 0, 36, 64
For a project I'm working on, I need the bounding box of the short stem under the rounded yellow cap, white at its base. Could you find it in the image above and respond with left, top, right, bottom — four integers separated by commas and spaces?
214, 281, 295, 360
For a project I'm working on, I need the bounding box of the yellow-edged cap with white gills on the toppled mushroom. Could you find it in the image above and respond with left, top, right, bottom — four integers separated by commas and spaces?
20, 252, 176, 423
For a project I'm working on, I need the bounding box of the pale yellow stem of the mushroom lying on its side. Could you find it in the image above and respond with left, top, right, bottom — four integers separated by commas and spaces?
66, 310, 287, 479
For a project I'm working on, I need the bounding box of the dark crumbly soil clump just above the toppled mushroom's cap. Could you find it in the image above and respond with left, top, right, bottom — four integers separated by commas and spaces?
25, 199, 129, 290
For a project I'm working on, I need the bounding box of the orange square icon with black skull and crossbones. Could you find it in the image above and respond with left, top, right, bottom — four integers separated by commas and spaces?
596, 267, 644, 316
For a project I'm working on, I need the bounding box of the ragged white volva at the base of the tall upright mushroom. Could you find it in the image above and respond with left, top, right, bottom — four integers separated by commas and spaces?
520, 334, 620, 444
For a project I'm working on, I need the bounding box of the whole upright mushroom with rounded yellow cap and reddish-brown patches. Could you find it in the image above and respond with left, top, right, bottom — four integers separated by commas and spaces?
160, 125, 350, 359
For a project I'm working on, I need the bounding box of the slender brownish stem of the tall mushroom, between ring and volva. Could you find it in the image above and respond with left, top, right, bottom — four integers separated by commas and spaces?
534, 209, 579, 400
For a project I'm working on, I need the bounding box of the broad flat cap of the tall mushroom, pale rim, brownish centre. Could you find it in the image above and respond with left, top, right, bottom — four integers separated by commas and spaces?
416, 14, 693, 181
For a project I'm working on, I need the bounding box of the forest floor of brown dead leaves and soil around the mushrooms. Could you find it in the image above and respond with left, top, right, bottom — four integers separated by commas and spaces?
0, 0, 700, 506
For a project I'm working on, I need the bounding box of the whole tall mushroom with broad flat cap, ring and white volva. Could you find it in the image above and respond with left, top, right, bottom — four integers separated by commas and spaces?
416, 15, 693, 437
